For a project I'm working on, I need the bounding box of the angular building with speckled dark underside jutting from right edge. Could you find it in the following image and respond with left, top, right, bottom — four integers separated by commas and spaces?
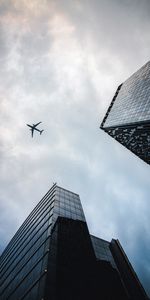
100, 61, 150, 164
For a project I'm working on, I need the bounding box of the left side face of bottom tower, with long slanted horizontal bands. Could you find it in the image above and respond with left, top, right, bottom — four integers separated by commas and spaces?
0, 183, 55, 300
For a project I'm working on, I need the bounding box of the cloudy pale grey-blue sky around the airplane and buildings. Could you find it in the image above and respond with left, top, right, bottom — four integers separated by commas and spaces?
0, 0, 150, 294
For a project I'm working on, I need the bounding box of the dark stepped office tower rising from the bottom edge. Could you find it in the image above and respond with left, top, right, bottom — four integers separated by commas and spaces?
0, 184, 148, 300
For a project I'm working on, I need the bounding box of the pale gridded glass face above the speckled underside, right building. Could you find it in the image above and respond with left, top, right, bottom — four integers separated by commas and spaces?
104, 61, 150, 127
